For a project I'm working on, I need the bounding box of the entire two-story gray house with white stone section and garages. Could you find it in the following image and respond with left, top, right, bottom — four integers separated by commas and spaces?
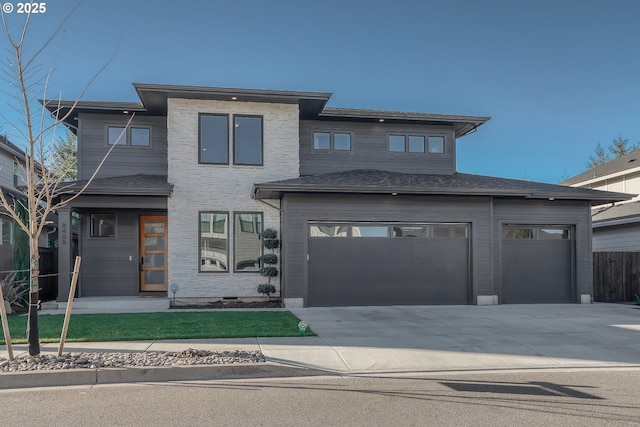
48, 84, 630, 307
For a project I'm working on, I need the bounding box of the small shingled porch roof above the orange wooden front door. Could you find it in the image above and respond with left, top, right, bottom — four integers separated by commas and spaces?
60, 174, 173, 196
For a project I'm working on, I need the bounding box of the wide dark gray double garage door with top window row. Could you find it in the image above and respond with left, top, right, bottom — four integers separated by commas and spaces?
308, 223, 470, 306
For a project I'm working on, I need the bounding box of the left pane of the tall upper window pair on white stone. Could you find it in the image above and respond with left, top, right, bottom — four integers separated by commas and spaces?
199, 114, 229, 164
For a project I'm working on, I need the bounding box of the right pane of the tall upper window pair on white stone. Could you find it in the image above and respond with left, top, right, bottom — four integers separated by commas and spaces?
233, 116, 262, 165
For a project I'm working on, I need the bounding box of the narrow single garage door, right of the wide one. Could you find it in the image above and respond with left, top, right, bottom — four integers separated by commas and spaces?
501, 225, 574, 304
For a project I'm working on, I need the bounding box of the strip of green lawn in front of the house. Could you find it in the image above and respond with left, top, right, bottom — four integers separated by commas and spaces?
0, 311, 315, 344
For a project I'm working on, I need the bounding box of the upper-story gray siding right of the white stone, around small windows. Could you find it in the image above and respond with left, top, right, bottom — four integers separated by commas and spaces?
300, 120, 456, 175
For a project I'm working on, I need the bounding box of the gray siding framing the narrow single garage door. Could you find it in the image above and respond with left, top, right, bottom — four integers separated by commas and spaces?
493, 200, 593, 302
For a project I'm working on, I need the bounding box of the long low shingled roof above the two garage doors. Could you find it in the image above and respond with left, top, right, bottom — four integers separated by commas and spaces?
253, 169, 633, 204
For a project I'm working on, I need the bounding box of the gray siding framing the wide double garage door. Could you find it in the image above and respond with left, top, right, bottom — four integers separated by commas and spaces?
281, 195, 493, 303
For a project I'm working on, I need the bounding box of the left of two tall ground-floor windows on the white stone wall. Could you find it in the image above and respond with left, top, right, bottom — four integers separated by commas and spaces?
200, 212, 229, 272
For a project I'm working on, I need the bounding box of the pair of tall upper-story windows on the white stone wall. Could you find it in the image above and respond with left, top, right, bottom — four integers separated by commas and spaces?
198, 113, 263, 165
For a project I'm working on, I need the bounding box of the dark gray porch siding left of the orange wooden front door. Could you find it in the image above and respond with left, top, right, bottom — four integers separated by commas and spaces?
79, 209, 167, 297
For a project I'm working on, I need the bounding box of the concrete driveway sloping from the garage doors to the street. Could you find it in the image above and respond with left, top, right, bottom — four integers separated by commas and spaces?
278, 304, 640, 373
